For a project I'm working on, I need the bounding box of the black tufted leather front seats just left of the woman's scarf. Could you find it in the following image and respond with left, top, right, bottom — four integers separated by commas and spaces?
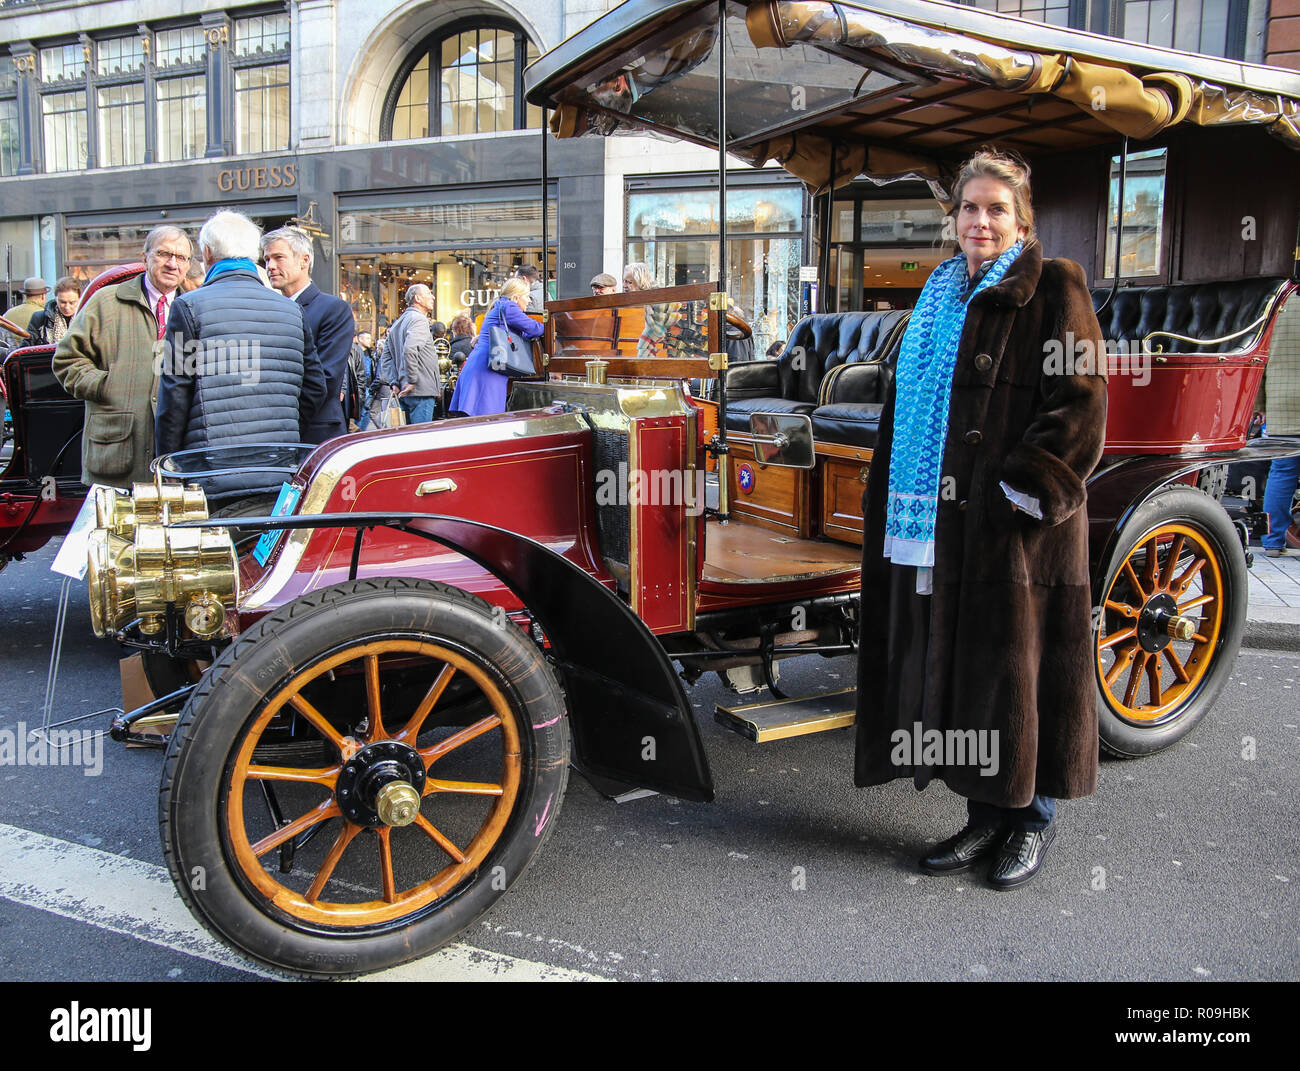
727, 309, 907, 432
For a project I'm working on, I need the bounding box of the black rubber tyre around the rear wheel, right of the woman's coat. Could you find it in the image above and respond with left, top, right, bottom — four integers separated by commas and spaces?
1093, 485, 1249, 759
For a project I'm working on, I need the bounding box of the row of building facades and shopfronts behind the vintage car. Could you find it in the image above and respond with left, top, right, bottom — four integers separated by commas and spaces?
0, 0, 1300, 337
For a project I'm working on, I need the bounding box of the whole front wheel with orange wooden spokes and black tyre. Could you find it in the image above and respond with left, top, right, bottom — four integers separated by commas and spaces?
161, 580, 568, 975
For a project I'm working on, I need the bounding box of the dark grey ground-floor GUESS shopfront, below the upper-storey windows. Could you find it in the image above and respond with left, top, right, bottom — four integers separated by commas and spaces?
0, 134, 601, 323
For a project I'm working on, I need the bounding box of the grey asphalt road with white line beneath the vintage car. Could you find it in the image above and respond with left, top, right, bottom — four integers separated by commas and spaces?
0, 548, 1300, 981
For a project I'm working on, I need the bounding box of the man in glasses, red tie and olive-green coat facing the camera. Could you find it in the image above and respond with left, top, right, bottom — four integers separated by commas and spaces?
53, 232, 194, 487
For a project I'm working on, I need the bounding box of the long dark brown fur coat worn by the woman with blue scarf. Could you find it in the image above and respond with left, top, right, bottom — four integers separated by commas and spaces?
855, 242, 1106, 807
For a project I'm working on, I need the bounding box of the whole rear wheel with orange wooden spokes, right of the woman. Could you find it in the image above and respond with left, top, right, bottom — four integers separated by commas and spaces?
1095, 486, 1248, 756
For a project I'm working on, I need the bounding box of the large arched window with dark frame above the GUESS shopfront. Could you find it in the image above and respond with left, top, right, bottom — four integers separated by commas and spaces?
380, 19, 542, 140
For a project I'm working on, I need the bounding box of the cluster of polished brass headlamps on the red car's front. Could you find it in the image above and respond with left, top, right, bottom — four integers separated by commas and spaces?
87, 484, 238, 639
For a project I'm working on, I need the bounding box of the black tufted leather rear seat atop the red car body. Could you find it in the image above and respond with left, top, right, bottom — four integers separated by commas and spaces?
1092, 278, 1286, 354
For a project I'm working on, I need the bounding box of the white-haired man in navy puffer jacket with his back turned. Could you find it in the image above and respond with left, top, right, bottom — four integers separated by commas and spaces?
155, 212, 325, 499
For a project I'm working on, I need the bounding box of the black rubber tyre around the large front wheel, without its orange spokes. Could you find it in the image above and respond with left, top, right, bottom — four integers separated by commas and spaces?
159, 578, 569, 977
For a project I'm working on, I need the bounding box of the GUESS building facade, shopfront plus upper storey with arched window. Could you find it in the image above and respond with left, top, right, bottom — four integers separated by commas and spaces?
0, 0, 603, 323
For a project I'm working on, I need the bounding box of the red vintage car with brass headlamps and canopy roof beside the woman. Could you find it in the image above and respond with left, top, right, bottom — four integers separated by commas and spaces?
73, 0, 1300, 975
